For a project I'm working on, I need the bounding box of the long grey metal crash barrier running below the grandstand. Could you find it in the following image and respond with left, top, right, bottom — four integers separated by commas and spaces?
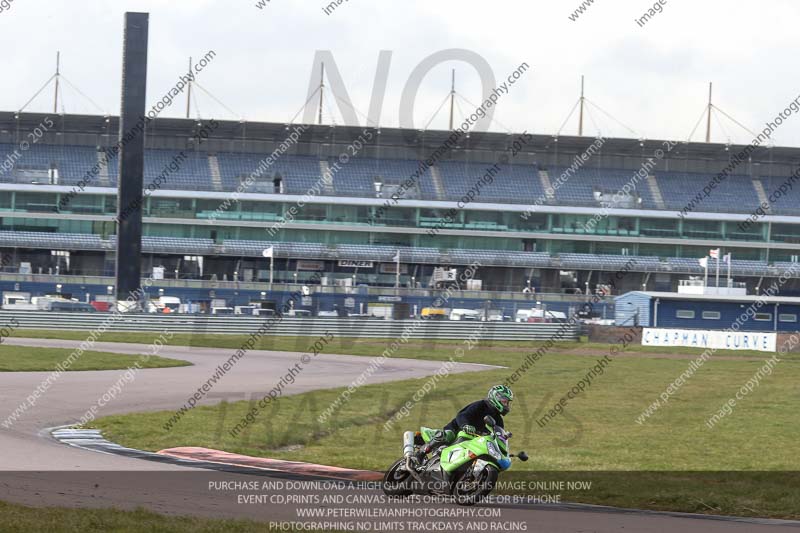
0, 311, 578, 341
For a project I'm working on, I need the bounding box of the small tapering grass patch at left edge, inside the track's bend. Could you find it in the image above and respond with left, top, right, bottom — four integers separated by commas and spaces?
0, 342, 191, 372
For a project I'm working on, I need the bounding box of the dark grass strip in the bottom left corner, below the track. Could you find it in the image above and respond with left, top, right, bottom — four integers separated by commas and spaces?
0, 501, 328, 533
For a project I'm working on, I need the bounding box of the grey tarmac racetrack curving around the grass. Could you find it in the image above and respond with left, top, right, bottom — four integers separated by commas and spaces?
0, 338, 800, 533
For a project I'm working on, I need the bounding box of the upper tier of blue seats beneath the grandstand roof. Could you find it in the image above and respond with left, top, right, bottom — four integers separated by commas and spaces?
0, 144, 800, 215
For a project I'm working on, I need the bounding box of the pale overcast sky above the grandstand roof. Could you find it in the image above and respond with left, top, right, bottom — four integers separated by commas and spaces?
0, 0, 800, 146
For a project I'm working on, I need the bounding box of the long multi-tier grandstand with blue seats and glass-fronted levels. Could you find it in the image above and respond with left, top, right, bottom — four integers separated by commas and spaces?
0, 109, 800, 306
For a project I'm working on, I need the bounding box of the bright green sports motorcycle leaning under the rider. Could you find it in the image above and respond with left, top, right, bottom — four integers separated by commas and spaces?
383, 416, 528, 505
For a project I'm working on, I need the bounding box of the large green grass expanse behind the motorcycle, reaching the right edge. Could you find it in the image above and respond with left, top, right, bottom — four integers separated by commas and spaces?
45, 335, 800, 518
